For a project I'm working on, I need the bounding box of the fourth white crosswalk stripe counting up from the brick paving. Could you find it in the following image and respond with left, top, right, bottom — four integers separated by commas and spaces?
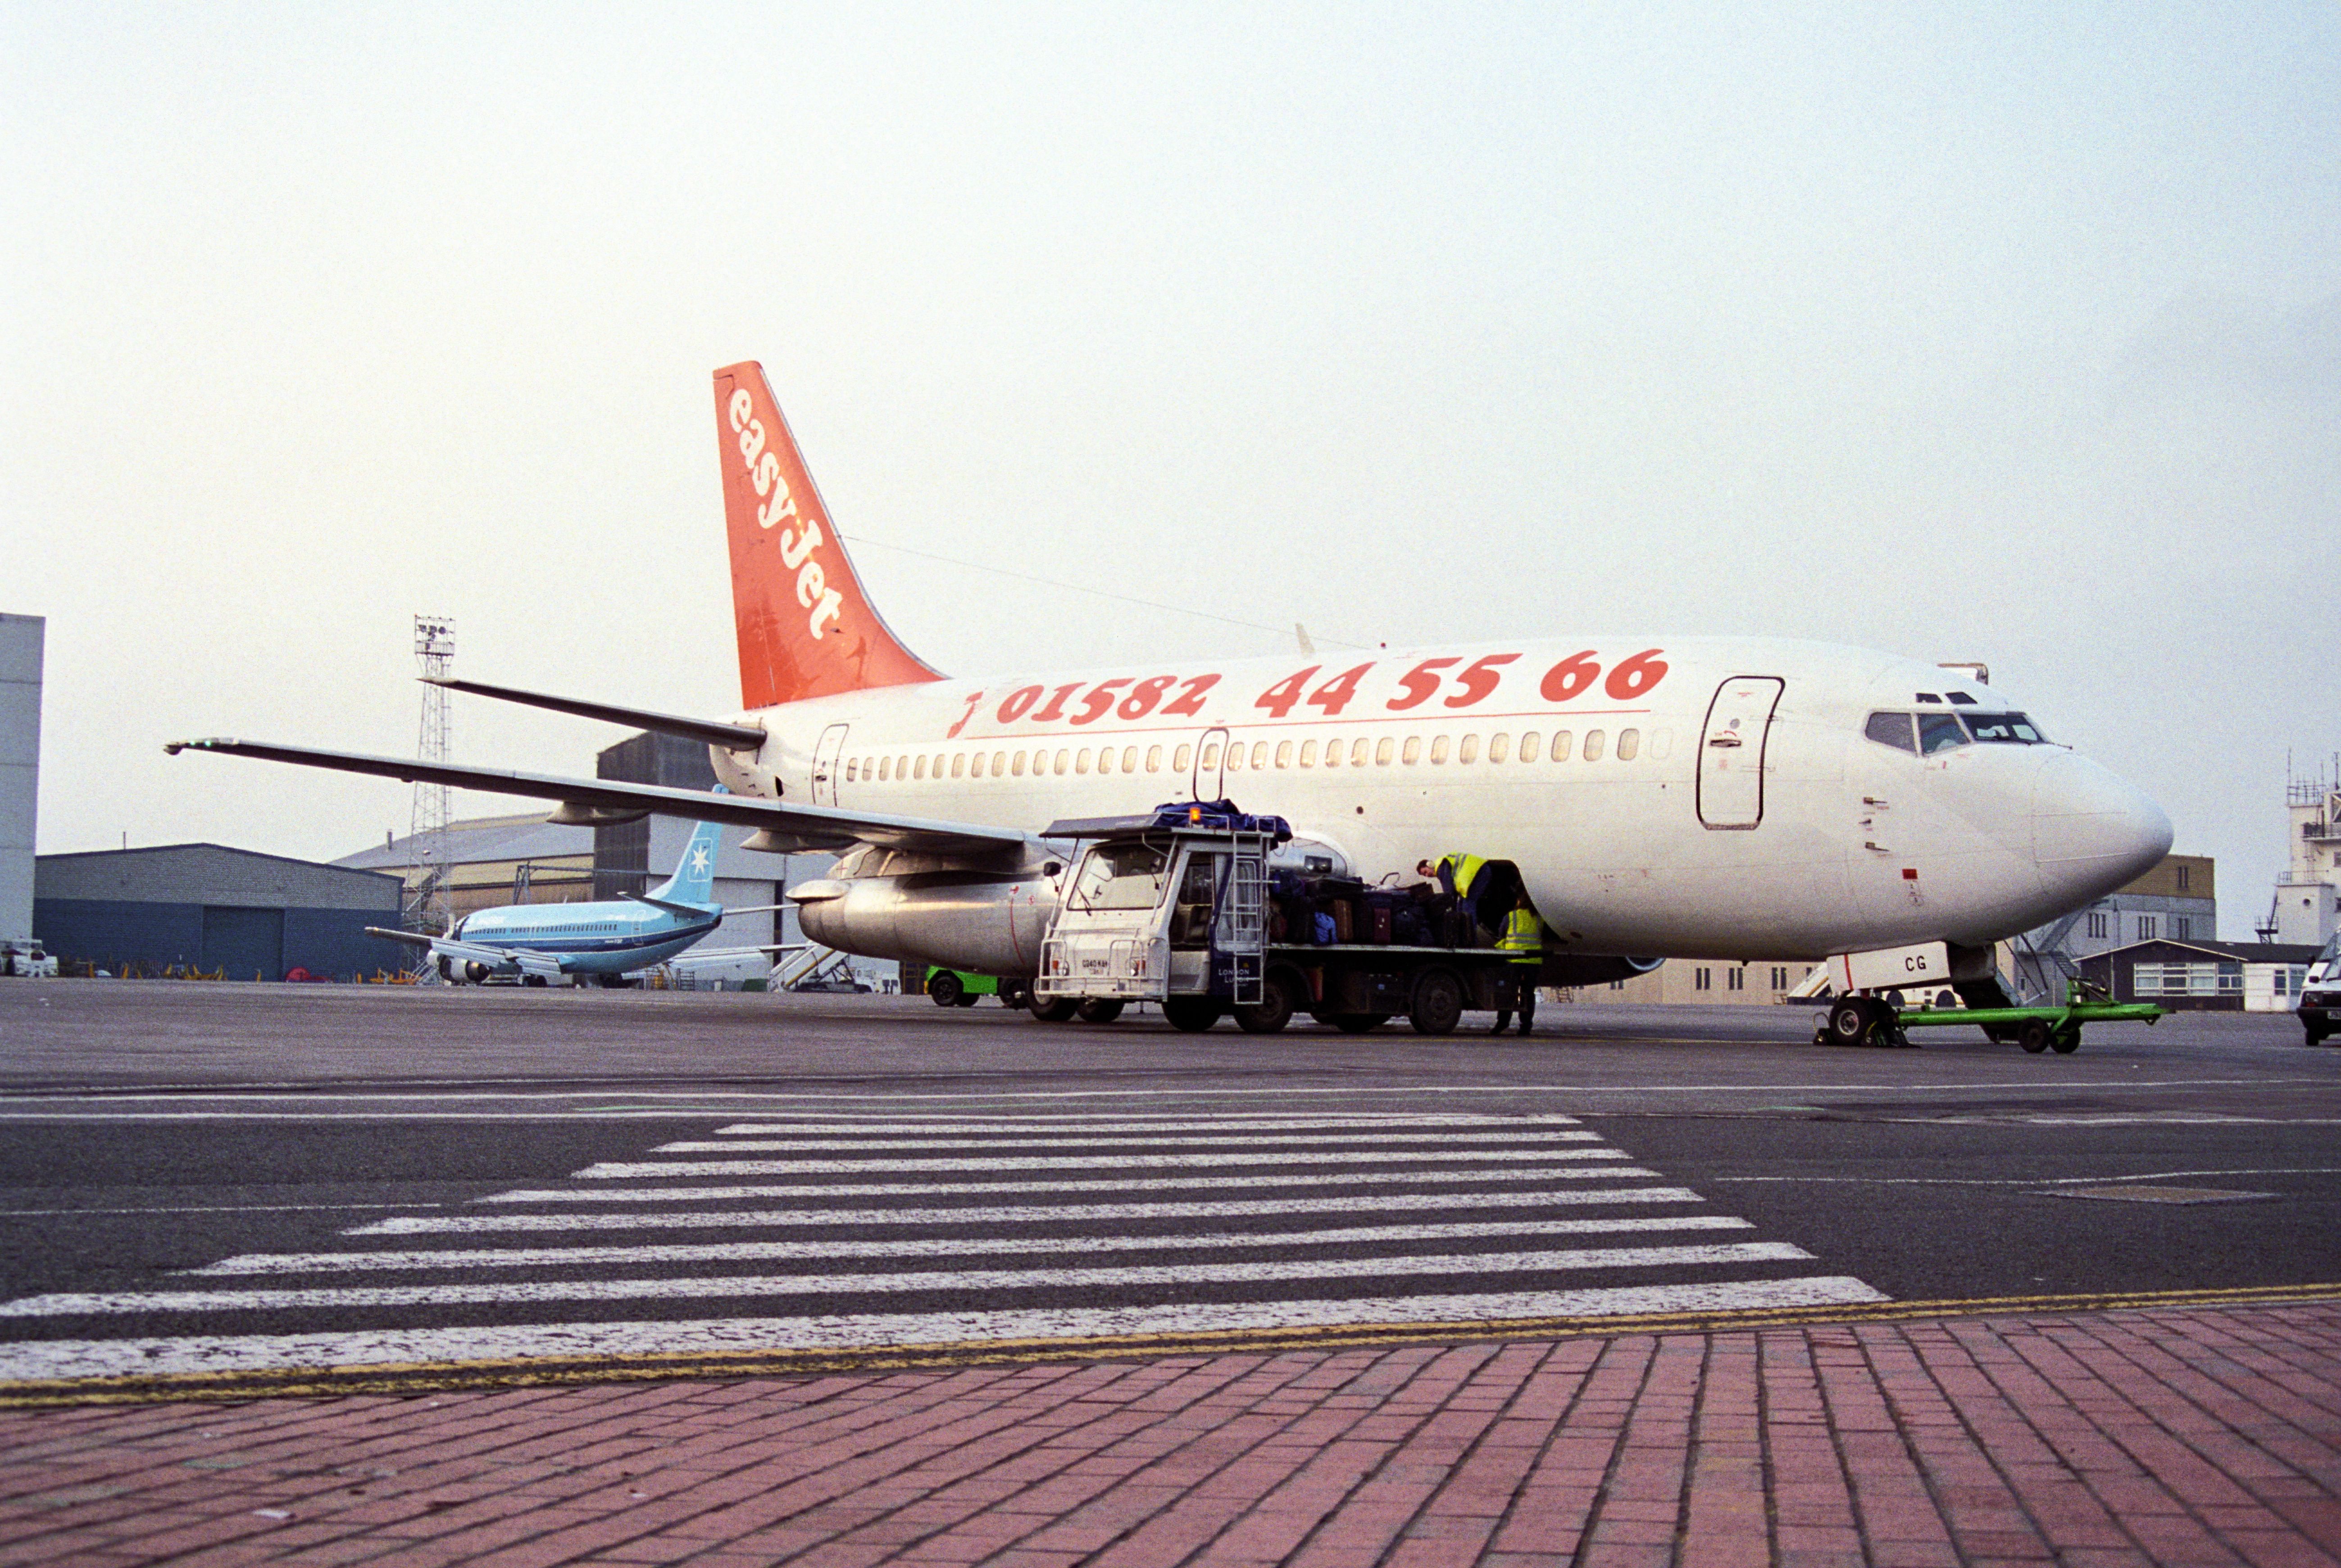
342, 1186, 1700, 1236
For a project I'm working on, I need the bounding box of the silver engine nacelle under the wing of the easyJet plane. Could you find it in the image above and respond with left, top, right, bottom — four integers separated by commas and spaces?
789, 850, 1063, 976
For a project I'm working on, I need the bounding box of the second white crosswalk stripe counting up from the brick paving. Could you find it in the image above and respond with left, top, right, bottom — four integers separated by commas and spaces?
0, 1241, 1812, 1318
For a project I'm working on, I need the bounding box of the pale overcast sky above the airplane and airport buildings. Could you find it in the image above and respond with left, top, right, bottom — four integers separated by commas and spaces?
0, 0, 2341, 936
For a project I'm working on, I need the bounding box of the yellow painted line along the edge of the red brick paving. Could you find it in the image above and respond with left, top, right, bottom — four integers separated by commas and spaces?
0, 1282, 2341, 1409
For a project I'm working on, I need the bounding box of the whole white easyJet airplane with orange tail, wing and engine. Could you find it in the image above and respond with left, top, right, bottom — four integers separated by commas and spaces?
171, 363, 2170, 1039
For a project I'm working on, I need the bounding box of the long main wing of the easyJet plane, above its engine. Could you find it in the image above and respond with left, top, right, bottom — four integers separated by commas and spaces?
164, 740, 1030, 854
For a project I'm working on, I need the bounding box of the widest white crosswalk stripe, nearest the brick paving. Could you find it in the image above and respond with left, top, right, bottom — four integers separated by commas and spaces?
0, 1276, 1887, 1381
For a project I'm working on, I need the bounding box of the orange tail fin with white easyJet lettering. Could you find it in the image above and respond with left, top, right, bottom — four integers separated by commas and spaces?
716, 360, 943, 709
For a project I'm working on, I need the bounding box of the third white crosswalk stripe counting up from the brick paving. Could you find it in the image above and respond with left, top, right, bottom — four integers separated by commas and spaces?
196, 1214, 1754, 1276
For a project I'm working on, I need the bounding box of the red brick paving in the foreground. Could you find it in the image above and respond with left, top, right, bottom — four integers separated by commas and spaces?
0, 1304, 2341, 1568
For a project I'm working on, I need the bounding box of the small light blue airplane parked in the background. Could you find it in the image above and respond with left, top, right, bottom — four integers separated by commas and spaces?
368, 822, 775, 985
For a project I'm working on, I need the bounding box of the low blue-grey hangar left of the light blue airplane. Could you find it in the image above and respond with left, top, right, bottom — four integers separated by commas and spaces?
33, 845, 409, 981
